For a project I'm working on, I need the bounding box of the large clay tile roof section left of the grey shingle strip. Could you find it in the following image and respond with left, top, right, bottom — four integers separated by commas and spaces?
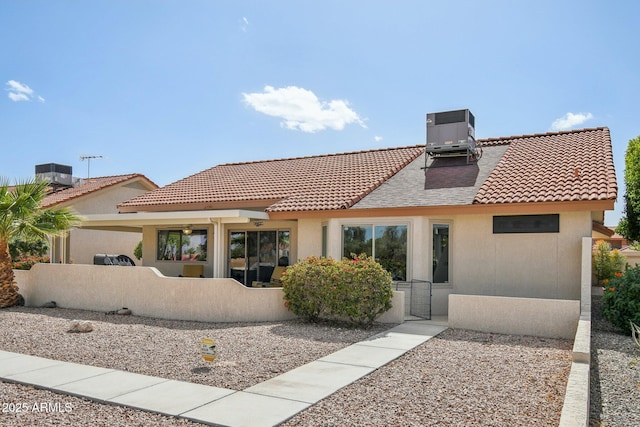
119, 146, 424, 212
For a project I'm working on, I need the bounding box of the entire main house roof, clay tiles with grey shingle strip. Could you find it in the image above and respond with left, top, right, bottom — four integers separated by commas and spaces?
119, 127, 617, 212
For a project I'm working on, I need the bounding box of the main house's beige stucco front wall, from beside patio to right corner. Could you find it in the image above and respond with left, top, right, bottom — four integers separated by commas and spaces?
298, 212, 591, 315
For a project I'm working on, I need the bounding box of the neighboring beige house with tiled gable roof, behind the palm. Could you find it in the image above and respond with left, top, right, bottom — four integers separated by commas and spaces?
42, 174, 158, 264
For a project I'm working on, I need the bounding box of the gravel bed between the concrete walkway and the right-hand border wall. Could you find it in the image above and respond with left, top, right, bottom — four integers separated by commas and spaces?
284, 329, 572, 426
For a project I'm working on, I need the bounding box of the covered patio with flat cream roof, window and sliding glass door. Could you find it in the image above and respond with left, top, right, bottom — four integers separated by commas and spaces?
80, 209, 296, 286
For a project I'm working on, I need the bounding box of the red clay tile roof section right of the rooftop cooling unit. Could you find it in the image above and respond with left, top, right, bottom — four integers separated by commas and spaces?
473, 127, 618, 204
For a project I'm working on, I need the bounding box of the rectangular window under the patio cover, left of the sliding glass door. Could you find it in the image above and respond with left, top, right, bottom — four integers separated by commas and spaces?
158, 230, 207, 262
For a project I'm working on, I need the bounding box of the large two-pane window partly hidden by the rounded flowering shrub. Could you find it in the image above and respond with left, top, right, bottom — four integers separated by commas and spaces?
342, 225, 407, 280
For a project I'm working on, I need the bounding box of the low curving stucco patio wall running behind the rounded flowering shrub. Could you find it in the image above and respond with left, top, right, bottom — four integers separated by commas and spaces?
15, 264, 404, 323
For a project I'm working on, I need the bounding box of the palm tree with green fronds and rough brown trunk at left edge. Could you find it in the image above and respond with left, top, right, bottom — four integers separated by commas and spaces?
0, 179, 80, 308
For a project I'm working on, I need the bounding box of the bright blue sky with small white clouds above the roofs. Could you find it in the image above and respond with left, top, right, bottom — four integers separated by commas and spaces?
0, 0, 640, 224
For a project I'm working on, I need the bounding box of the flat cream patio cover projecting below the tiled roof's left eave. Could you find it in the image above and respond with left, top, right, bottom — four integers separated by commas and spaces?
79, 209, 269, 233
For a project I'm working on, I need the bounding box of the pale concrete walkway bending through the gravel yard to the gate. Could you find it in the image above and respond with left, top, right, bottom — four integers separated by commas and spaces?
0, 321, 447, 427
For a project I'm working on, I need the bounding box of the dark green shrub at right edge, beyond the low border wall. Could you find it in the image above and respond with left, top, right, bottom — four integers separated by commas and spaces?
602, 265, 640, 332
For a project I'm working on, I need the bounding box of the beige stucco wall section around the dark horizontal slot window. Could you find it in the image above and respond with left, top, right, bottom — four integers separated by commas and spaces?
452, 212, 591, 300
